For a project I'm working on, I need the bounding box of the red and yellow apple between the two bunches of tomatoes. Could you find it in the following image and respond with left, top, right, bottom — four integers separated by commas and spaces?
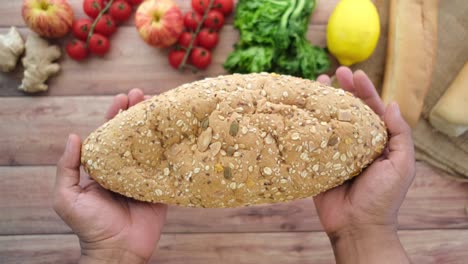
135, 0, 184, 48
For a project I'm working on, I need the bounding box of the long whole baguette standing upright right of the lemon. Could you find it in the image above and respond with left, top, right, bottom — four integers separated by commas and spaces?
382, 0, 439, 127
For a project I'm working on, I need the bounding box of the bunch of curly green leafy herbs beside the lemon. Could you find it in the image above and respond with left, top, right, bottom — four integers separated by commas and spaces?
224, 0, 330, 79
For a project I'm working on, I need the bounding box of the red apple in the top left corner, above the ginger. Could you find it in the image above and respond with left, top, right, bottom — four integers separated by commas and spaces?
21, 0, 73, 38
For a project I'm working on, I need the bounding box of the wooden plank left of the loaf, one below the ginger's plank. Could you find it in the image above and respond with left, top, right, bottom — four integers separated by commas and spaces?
0, 96, 112, 165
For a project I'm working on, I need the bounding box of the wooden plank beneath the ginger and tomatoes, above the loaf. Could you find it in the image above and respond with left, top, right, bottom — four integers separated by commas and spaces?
0, 25, 326, 97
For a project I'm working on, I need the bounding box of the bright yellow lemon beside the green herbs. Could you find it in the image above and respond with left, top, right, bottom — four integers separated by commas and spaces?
327, 0, 380, 66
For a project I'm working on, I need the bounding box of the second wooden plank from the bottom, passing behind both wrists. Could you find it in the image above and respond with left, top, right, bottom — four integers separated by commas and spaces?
0, 163, 468, 235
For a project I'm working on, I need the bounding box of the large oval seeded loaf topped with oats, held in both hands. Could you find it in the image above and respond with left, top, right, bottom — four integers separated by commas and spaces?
81, 73, 387, 208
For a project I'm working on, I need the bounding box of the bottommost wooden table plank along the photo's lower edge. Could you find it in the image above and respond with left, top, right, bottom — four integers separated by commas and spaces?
0, 230, 468, 264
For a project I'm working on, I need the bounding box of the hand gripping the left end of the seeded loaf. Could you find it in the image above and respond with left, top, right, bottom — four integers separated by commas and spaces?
54, 89, 167, 263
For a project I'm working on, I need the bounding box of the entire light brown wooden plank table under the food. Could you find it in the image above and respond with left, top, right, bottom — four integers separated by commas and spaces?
0, 0, 468, 264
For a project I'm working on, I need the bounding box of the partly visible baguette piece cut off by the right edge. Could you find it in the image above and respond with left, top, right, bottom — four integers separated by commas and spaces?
429, 62, 468, 137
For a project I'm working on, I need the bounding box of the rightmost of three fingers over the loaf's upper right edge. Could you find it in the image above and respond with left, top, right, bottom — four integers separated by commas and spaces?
354, 70, 385, 116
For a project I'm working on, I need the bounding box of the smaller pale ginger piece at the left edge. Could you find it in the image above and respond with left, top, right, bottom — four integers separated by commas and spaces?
0, 27, 24, 72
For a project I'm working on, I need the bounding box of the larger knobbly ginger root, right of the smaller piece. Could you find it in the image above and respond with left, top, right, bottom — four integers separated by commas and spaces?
18, 35, 61, 93
